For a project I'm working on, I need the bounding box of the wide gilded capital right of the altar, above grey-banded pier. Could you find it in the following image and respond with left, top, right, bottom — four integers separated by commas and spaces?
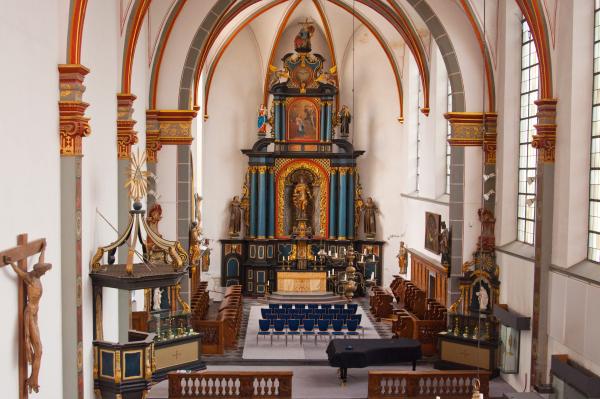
444, 112, 498, 147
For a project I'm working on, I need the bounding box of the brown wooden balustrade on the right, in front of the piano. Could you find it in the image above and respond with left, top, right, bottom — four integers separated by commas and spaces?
369, 370, 490, 399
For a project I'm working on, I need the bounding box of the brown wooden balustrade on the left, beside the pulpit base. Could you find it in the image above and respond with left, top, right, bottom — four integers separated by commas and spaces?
169, 371, 293, 399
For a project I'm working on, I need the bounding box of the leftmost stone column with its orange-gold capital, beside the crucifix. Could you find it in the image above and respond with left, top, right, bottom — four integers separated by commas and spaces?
58, 64, 91, 399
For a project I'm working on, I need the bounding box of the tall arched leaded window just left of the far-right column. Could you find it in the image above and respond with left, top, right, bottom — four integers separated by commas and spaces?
517, 18, 539, 244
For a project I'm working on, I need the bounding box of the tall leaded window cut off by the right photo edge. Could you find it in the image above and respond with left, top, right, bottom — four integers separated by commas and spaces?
588, 0, 600, 262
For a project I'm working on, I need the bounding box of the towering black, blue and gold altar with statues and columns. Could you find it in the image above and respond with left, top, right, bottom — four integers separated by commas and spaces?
221, 23, 383, 295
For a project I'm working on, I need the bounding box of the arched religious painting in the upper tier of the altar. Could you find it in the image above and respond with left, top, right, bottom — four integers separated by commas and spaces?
286, 97, 320, 142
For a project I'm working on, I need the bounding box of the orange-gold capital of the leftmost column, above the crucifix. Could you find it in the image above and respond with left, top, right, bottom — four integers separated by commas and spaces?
58, 64, 91, 157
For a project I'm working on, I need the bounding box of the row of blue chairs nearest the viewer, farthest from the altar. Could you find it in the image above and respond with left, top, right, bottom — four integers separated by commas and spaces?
256, 319, 364, 346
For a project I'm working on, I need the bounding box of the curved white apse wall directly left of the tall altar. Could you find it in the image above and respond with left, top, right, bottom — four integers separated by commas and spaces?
200, 27, 264, 289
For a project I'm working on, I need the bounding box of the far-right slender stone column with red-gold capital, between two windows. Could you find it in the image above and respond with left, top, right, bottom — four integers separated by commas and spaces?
531, 98, 558, 391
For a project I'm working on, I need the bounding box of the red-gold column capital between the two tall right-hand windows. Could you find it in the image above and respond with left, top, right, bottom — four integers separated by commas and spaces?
531, 98, 558, 163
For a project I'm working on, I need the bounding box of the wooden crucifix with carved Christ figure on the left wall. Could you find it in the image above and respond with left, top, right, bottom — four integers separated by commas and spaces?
0, 234, 52, 399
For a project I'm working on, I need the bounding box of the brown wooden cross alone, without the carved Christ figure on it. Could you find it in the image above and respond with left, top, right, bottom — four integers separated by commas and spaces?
0, 234, 46, 399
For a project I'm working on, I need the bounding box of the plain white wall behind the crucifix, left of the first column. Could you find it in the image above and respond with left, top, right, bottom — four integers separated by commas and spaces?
0, 0, 67, 398
